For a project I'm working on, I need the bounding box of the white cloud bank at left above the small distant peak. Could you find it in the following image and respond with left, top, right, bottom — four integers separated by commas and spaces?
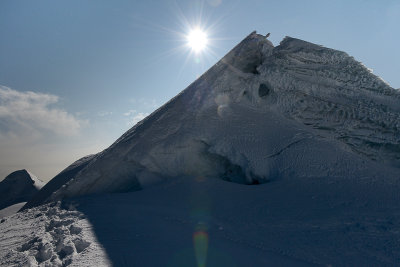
0, 86, 86, 138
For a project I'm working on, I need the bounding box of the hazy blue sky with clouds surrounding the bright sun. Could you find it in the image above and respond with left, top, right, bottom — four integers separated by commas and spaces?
0, 0, 400, 180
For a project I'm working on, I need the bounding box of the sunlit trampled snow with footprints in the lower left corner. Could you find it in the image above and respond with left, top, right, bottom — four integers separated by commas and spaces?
0, 203, 110, 266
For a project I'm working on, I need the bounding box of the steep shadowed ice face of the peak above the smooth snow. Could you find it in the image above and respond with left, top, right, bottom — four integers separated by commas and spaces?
28, 32, 400, 204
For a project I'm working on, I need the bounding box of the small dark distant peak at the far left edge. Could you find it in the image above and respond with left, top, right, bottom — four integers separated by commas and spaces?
0, 170, 44, 210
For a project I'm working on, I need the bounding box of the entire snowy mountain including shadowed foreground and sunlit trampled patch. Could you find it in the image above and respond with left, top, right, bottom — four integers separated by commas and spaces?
0, 33, 400, 266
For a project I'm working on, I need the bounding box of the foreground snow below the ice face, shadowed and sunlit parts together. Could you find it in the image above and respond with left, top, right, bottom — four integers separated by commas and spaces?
0, 177, 400, 267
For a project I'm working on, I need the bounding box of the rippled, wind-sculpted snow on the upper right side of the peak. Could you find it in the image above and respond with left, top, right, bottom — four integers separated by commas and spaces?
266, 35, 400, 167
